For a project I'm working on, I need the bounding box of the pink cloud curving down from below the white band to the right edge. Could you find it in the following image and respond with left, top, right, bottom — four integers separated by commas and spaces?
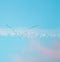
30, 39, 60, 59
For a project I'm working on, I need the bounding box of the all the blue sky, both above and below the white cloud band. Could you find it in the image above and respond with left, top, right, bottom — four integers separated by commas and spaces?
0, 0, 60, 62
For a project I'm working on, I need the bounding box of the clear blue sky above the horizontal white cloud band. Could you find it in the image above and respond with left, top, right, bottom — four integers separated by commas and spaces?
0, 0, 60, 29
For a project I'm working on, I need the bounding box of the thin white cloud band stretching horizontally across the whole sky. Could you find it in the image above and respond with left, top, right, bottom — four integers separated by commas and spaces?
0, 28, 60, 38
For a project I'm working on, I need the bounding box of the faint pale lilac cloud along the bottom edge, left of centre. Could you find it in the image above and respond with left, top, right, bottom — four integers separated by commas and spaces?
12, 54, 41, 62
